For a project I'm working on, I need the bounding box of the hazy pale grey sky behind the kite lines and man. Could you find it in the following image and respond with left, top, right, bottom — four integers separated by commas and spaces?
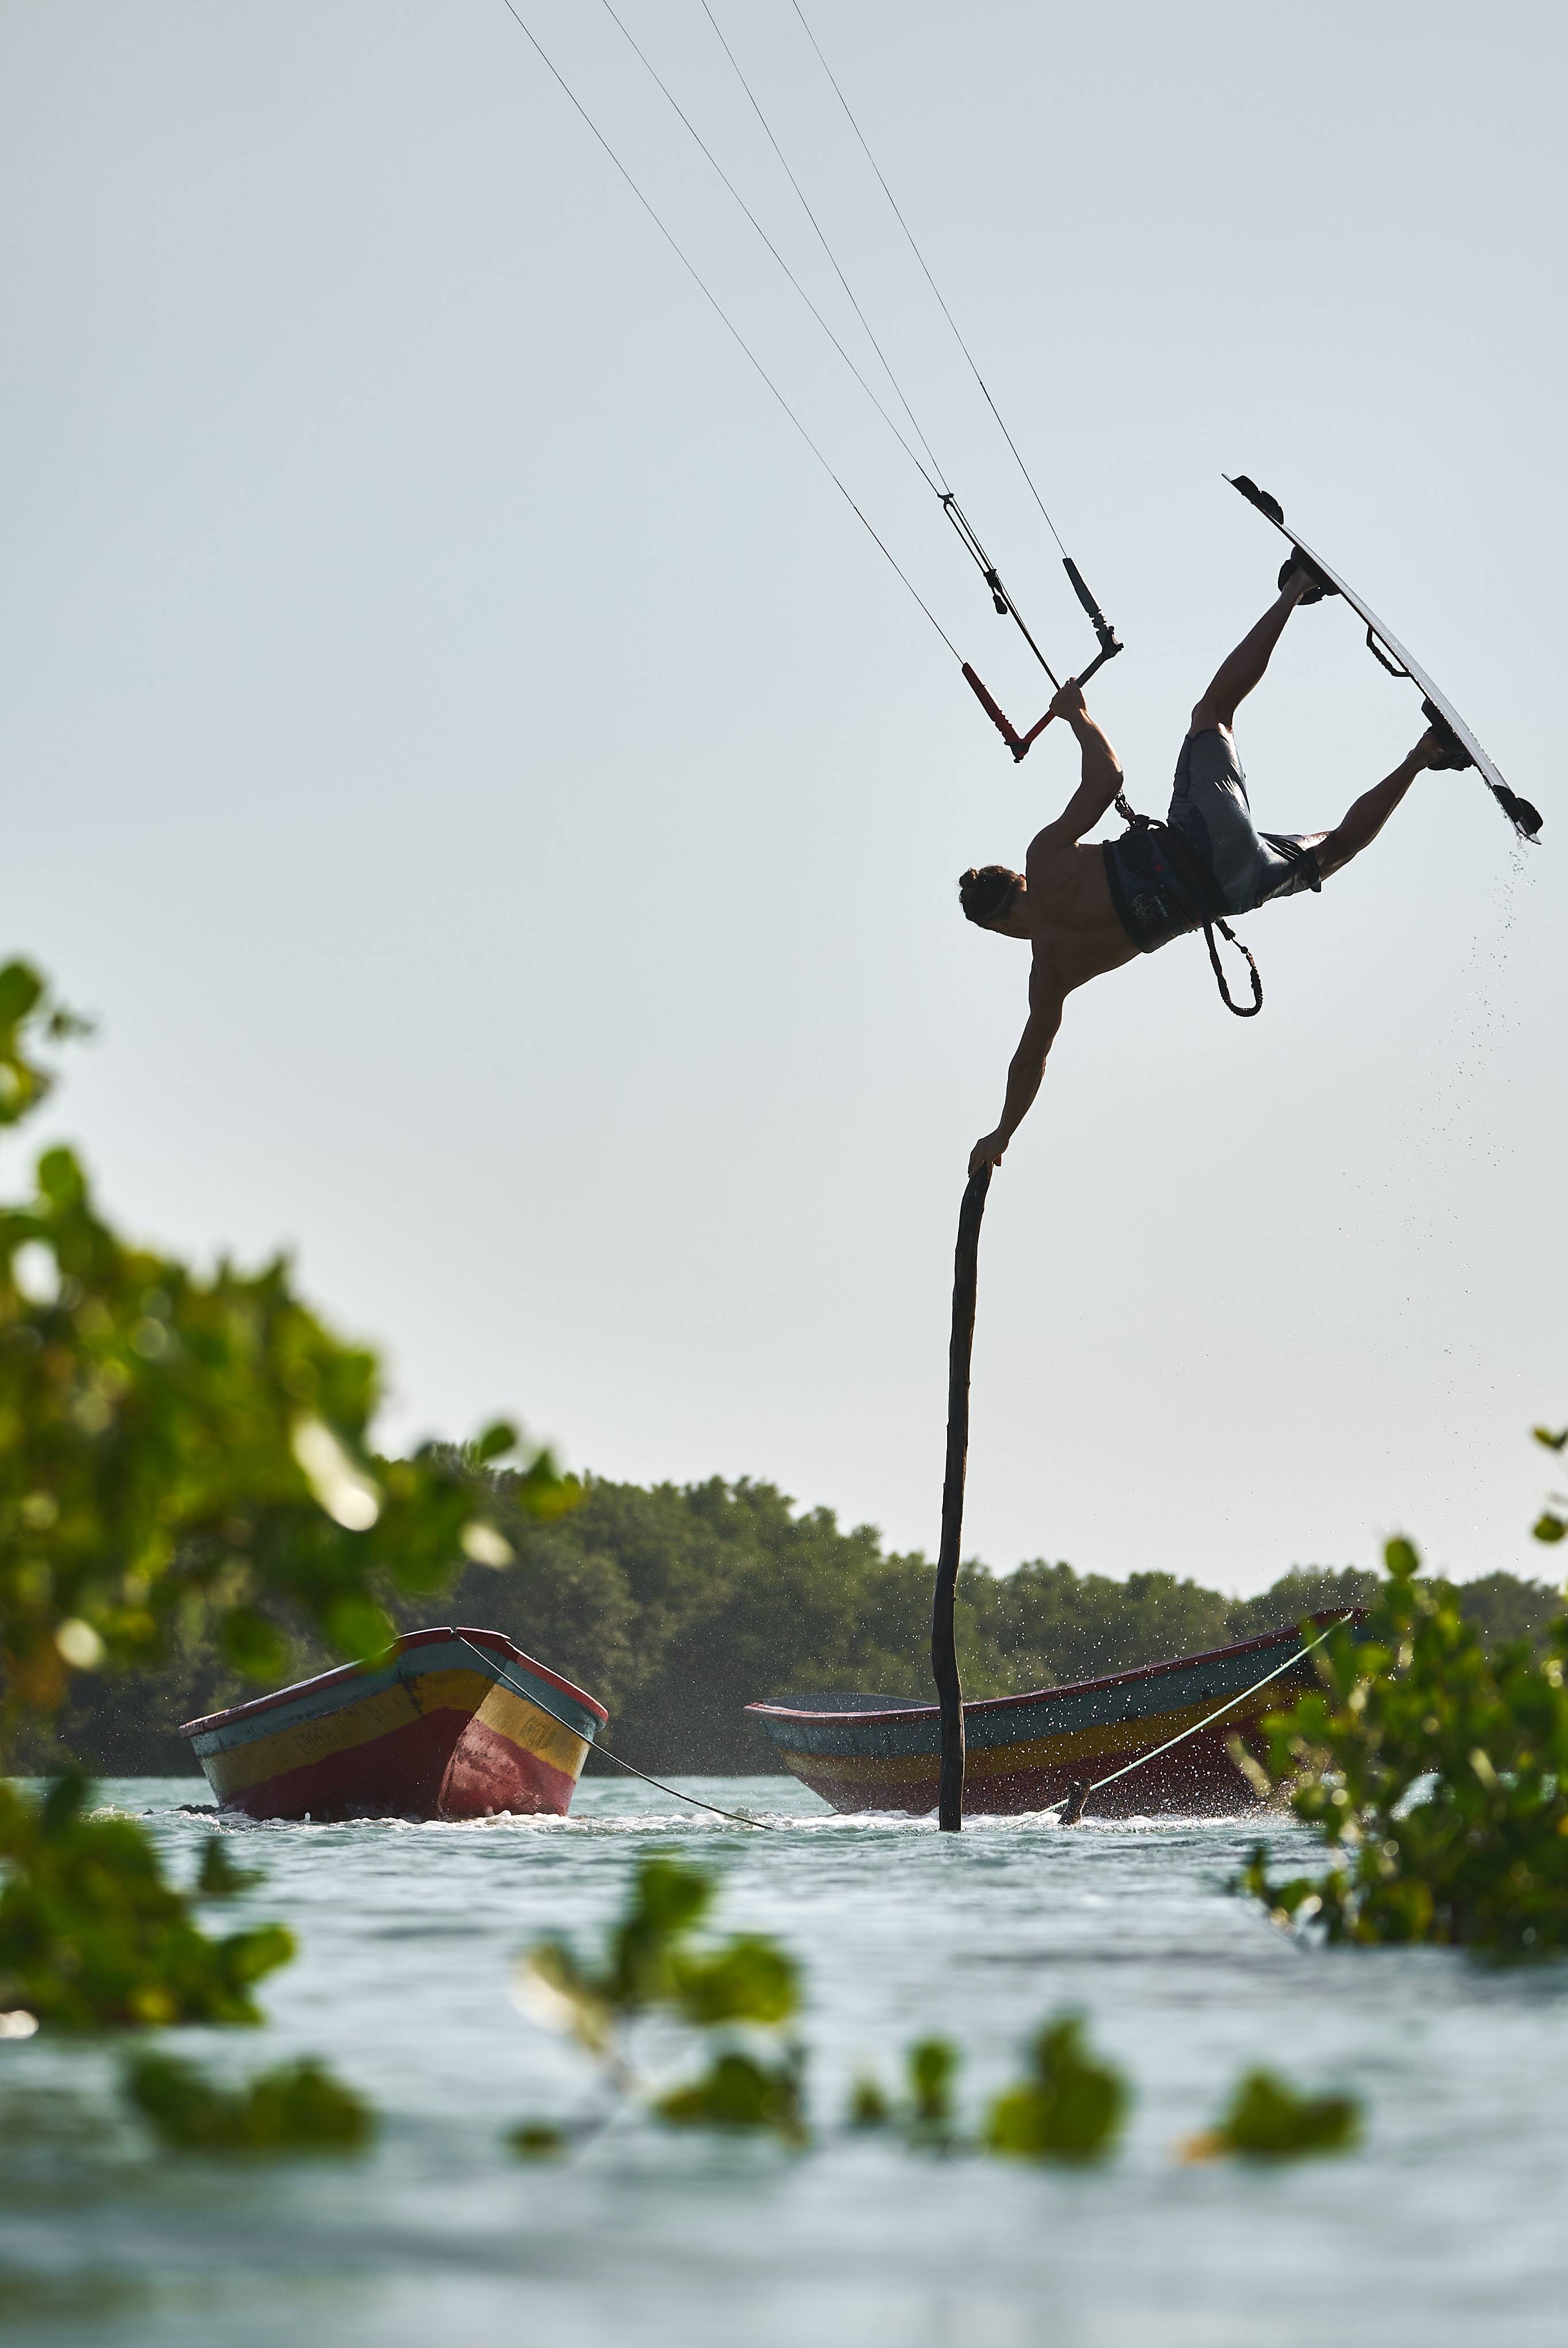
0, 0, 1568, 1590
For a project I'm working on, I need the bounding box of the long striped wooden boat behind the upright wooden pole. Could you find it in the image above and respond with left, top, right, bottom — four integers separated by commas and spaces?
747, 1611, 1359, 1817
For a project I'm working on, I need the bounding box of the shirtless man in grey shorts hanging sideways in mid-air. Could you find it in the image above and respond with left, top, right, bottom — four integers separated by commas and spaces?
957, 559, 1458, 1174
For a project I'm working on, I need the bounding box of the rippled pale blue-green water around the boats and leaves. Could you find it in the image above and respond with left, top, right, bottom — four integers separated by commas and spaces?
0, 1778, 1568, 2348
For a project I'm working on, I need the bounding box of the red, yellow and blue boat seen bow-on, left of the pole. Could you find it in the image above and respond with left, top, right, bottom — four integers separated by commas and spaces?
181, 1629, 608, 1819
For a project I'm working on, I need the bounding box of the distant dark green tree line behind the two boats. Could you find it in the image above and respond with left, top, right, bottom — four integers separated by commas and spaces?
19, 1470, 1561, 1775
